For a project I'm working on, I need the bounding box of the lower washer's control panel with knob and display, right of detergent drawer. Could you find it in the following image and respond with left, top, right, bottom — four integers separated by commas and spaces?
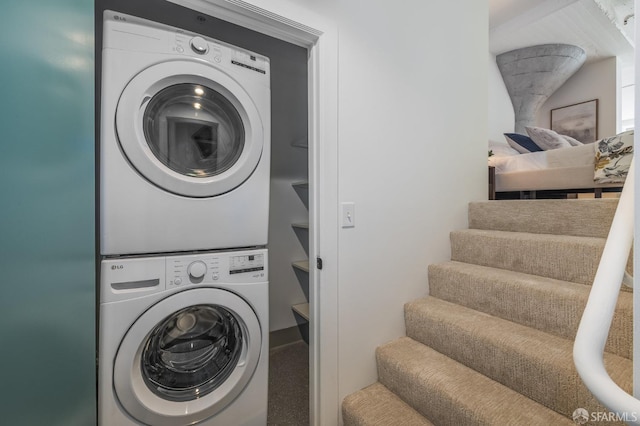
166, 250, 267, 288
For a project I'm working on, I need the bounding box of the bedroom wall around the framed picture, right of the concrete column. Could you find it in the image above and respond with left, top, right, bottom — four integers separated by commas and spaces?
536, 57, 618, 138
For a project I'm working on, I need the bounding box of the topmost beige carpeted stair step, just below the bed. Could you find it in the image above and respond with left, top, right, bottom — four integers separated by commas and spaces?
469, 199, 618, 238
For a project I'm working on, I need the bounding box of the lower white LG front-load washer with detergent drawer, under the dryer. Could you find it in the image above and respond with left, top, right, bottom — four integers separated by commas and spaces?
98, 249, 269, 426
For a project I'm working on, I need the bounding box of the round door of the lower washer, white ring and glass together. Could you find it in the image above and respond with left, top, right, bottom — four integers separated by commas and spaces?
113, 288, 262, 426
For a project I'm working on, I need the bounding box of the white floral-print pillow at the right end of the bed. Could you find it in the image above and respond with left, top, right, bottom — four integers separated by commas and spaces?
593, 130, 633, 183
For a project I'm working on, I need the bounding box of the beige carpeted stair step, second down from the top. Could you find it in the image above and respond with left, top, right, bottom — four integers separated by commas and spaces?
451, 229, 605, 285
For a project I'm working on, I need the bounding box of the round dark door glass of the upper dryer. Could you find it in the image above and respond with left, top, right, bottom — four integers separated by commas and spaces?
143, 83, 245, 177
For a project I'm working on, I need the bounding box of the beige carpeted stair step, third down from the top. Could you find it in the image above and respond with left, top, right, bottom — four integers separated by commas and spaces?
429, 261, 633, 359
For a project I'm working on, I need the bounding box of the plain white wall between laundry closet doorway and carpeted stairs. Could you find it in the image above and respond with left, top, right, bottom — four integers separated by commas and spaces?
336, 0, 488, 410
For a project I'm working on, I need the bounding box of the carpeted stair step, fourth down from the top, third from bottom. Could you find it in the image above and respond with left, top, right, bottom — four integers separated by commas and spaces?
404, 297, 633, 416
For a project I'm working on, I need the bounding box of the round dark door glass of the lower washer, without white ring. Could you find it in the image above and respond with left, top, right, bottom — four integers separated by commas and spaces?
141, 305, 243, 401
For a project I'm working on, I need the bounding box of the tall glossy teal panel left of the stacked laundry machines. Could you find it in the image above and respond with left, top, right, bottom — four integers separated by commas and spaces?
0, 0, 96, 426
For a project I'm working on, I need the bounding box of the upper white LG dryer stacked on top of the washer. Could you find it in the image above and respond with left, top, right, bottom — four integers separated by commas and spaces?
100, 11, 271, 255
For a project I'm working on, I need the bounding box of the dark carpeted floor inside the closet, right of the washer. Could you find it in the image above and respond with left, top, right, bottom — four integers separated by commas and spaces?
267, 341, 309, 426
